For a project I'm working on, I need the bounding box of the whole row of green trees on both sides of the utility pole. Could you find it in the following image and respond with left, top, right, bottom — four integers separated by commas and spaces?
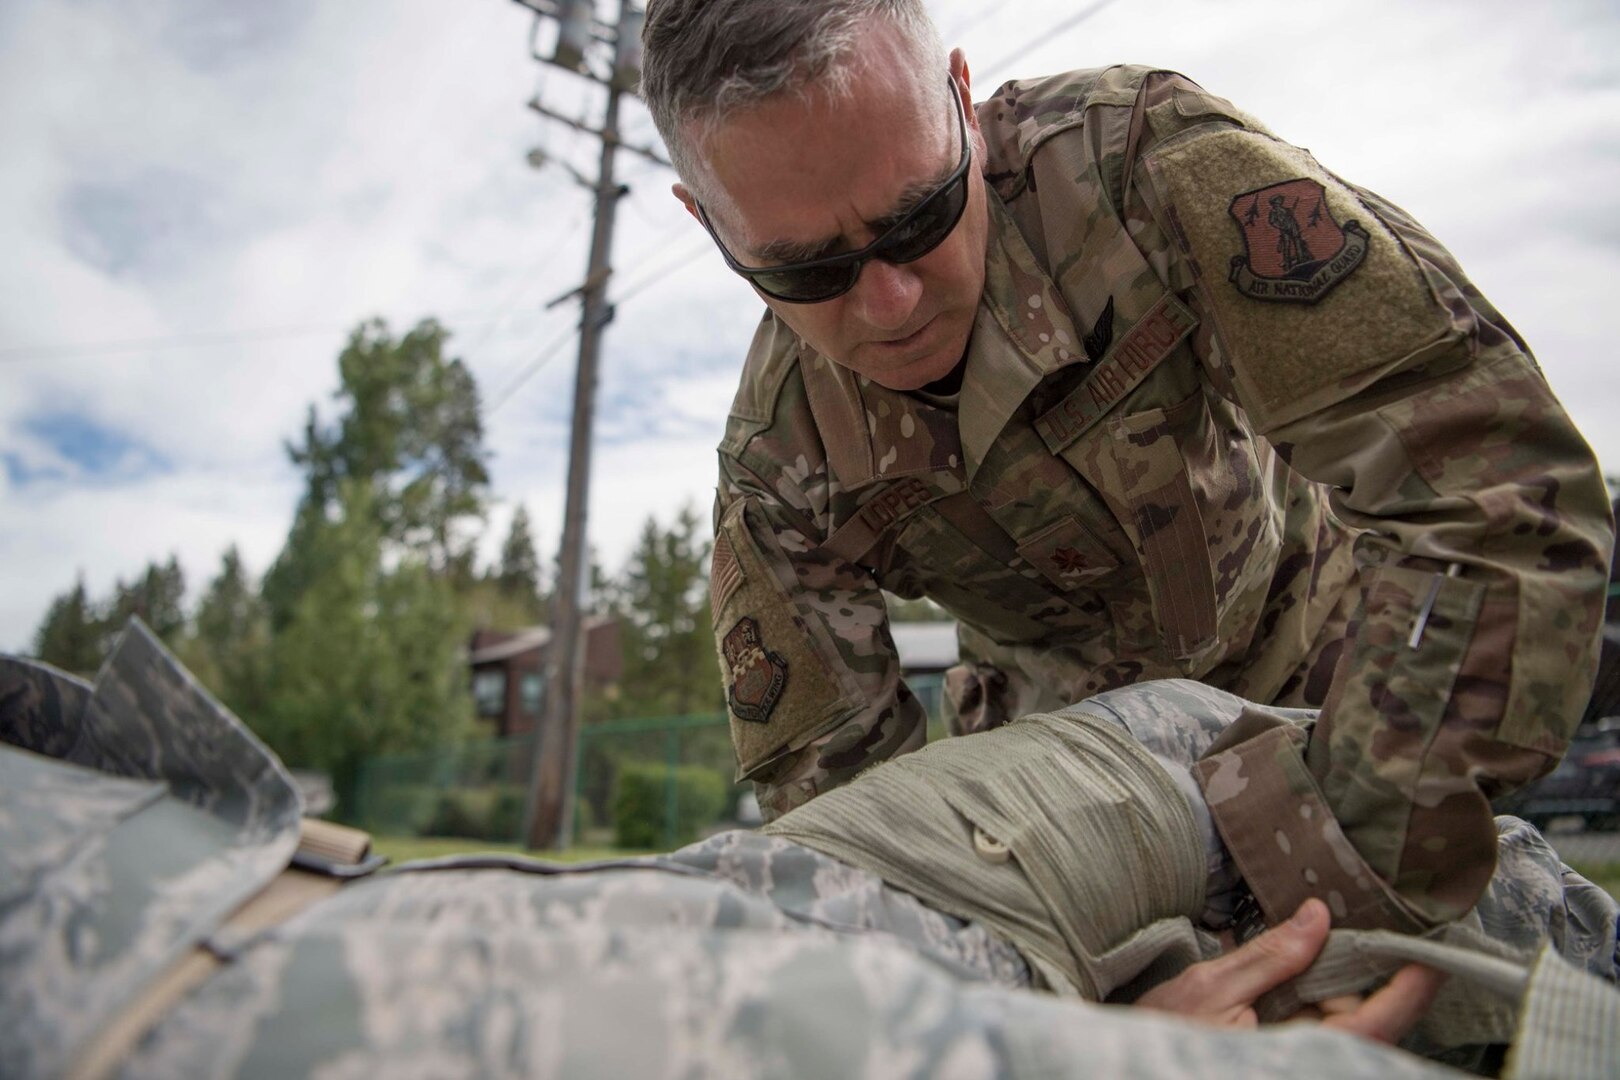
23, 319, 723, 787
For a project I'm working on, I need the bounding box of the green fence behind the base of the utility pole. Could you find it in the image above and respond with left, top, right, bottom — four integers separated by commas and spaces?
354, 714, 741, 848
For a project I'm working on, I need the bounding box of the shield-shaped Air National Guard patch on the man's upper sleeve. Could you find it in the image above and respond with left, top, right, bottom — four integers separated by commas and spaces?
1228, 176, 1367, 304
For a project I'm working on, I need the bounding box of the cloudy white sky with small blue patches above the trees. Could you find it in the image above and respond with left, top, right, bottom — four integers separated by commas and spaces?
0, 0, 1620, 649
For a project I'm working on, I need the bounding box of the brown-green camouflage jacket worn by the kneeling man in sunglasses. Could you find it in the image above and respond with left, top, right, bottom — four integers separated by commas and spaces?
713, 68, 1612, 929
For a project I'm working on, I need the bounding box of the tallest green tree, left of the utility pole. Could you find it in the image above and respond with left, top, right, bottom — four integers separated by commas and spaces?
247, 319, 489, 784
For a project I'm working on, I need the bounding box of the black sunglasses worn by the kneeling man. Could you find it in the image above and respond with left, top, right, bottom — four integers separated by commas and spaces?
697, 79, 974, 304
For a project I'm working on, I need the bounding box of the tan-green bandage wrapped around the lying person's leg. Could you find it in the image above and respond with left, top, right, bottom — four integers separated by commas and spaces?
766, 714, 1217, 1001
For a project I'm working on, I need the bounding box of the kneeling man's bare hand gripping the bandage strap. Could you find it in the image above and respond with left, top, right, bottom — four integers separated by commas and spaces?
1136, 899, 1445, 1043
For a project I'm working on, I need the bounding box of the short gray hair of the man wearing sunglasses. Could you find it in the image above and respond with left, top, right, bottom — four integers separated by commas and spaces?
642, 0, 944, 196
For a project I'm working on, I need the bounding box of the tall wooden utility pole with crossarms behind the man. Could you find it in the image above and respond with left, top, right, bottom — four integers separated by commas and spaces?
515, 0, 667, 848
